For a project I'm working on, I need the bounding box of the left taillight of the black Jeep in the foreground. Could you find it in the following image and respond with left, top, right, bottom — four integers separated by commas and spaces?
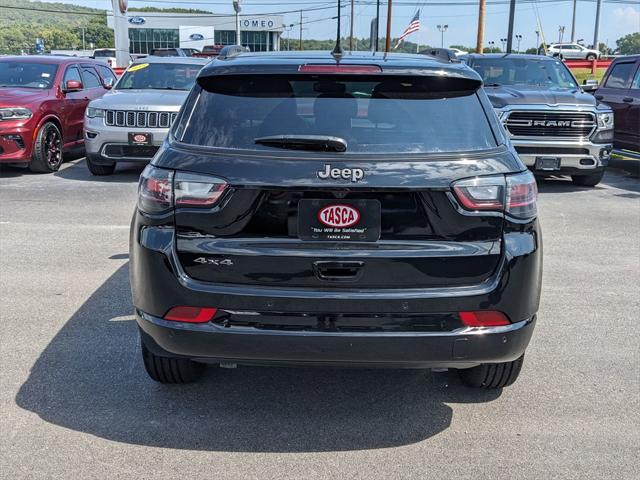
138, 165, 227, 215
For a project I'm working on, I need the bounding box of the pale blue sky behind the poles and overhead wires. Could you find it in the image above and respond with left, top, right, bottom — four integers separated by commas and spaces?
38, 0, 640, 50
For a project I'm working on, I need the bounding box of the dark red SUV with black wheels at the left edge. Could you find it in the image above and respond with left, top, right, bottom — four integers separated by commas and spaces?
0, 56, 116, 172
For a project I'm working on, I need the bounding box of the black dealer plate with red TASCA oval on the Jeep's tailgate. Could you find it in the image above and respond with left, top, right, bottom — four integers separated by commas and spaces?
298, 199, 381, 242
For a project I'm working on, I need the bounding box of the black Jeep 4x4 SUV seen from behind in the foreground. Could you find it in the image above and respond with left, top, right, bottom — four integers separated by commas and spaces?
131, 52, 542, 388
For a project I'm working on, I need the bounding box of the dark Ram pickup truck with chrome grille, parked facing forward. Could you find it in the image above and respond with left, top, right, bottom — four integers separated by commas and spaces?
464, 54, 613, 187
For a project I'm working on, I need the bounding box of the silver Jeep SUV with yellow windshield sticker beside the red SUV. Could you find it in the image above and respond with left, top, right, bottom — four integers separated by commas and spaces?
84, 56, 208, 175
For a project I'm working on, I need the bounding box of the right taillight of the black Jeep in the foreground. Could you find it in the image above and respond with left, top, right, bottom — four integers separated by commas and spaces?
453, 170, 538, 220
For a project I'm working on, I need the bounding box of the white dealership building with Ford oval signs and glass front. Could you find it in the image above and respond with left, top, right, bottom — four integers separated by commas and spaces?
107, 12, 284, 54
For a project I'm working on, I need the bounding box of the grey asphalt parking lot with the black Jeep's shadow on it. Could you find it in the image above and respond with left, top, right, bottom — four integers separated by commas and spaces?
0, 160, 640, 479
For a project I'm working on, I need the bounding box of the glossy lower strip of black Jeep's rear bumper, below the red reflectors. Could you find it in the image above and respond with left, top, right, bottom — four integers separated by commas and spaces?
136, 311, 535, 368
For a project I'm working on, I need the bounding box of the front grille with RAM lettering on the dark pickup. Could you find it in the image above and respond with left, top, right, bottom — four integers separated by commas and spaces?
505, 111, 596, 138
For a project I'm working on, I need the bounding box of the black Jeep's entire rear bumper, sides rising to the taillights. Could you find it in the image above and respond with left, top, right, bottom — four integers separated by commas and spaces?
130, 219, 542, 368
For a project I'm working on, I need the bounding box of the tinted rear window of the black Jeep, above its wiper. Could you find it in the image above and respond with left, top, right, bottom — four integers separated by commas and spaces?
174, 75, 497, 153
